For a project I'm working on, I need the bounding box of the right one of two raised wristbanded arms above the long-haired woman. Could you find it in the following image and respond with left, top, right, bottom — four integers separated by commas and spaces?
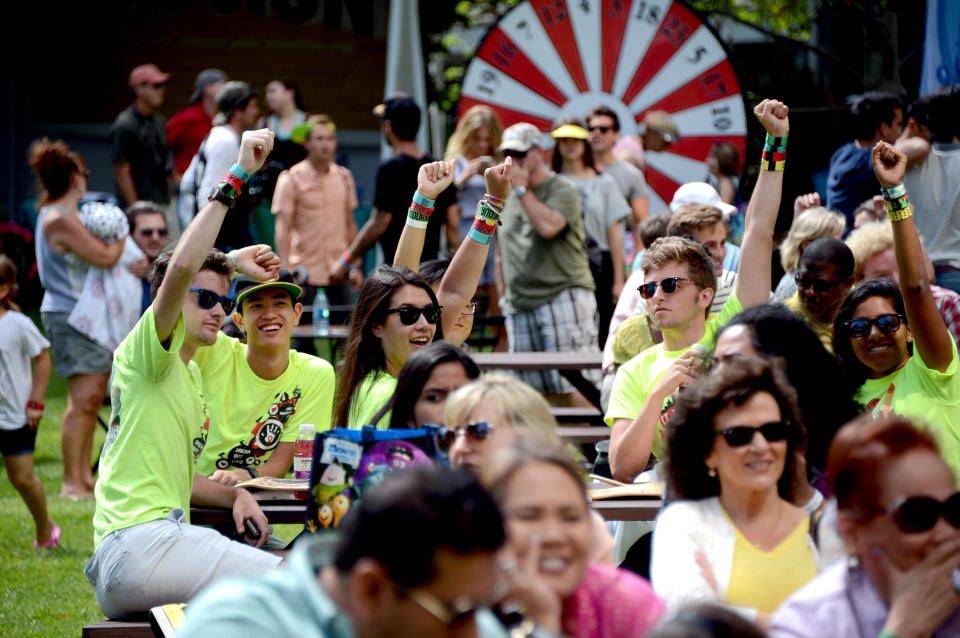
437, 157, 513, 345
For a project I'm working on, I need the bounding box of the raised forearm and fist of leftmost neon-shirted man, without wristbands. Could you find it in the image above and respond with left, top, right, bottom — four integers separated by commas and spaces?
153, 129, 274, 342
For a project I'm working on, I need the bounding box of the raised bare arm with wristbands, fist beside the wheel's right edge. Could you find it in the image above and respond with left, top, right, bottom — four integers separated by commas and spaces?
736, 100, 790, 308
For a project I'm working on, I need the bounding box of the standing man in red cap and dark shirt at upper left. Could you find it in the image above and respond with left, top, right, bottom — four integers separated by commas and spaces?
110, 64, 172, 206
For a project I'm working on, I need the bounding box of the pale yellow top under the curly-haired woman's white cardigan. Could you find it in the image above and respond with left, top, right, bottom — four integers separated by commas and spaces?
723, 512, 817, 612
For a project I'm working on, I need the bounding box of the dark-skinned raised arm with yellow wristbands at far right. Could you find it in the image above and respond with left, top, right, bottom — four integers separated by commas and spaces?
873, 142, 953, 372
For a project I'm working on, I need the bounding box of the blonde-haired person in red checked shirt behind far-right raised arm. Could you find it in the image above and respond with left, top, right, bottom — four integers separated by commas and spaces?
847, 222, 960, 343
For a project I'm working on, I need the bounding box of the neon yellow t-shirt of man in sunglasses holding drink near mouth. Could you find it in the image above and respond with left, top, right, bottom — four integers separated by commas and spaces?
603, 294, 743, 458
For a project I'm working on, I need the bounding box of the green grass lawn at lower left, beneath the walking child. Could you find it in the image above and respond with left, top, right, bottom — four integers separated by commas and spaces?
0, 321, 303, 638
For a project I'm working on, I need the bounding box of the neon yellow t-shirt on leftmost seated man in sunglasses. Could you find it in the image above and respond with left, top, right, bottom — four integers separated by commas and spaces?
93, 306, 207, 547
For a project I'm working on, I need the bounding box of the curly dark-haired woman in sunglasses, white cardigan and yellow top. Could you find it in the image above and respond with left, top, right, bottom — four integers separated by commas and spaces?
650, 357, 820, 627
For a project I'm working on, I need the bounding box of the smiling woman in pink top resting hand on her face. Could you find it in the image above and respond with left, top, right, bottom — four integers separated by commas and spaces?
483, 444, 664, 638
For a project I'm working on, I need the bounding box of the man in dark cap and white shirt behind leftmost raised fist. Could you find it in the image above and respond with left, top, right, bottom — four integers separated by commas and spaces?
180, 82, 259, 252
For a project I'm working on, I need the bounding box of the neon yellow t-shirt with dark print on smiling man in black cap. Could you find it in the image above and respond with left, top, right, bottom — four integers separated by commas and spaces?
193, 332, 335, 476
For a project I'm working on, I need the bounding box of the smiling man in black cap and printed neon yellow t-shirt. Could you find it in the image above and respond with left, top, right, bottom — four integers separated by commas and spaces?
193, 270, 334, 485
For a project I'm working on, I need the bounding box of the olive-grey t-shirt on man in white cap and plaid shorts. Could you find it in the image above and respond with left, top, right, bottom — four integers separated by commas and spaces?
497, 174, 594, 314
